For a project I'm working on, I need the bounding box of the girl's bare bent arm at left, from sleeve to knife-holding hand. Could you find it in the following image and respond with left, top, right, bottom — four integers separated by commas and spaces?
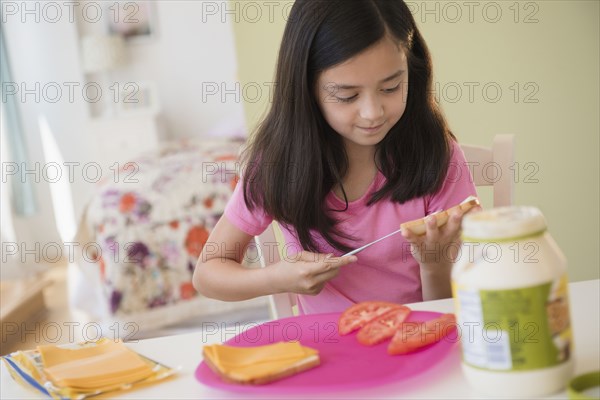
193, 216, 356, 301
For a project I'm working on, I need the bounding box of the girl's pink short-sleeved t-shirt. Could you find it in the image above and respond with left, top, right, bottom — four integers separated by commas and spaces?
225, 143, 476, 314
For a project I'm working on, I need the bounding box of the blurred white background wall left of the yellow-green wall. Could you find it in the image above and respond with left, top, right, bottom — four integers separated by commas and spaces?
2, 1, 243, 261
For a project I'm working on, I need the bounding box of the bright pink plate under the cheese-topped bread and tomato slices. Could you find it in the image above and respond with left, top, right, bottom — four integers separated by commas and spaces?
195, 311, 458, 394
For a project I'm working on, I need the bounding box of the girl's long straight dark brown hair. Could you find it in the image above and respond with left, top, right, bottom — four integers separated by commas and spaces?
243, 0, 453, 252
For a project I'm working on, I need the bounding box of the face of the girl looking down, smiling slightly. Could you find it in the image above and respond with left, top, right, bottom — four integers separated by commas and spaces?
317, 36, 408, 148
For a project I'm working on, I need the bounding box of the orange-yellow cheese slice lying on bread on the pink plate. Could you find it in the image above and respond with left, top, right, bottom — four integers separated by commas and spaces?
204, 342, 318, 380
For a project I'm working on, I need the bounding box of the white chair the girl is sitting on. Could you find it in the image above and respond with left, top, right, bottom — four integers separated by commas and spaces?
255, 135, 515, 319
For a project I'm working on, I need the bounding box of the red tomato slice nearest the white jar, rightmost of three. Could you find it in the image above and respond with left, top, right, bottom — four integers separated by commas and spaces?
388, 314, 456, 355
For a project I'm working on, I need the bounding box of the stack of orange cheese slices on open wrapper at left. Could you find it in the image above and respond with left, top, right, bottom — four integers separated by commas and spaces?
38, 341, 152, 389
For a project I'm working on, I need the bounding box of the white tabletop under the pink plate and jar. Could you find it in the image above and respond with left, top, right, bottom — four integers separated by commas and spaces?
0, 280, 600, 399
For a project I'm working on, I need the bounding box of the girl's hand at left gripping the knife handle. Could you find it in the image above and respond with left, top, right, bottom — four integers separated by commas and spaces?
269, 251, 357, 295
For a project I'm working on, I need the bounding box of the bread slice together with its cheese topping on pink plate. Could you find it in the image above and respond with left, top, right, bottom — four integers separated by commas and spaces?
203, 342, 320, 385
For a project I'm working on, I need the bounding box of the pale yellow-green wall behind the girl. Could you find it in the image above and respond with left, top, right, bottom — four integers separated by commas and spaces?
234, 1, 600, 281
